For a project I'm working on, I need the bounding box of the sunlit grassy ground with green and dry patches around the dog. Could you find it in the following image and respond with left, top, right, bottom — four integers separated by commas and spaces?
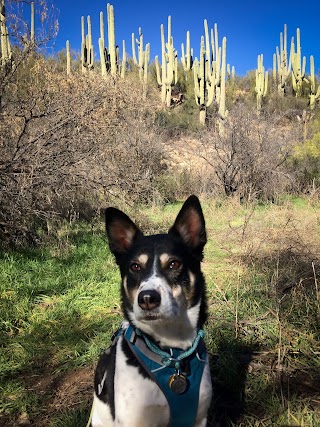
0, 198, 320, 427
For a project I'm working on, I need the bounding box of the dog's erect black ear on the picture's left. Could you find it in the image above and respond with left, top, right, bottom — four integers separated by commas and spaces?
105, 208, 143, 258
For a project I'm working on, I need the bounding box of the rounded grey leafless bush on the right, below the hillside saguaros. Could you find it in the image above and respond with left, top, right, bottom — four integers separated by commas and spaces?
201, 105, 293, 200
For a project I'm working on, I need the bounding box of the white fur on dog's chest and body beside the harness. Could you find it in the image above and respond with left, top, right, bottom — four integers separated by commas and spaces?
92, 336, 212, 427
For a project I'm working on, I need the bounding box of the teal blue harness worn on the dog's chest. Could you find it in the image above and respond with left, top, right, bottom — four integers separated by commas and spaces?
124, 325, 207, 427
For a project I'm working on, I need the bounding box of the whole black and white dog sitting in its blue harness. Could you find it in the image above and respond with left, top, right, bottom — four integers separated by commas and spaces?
91, 196, 212, 427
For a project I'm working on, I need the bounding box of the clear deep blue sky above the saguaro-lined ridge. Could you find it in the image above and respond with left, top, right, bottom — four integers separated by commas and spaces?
47, 0, 320, 75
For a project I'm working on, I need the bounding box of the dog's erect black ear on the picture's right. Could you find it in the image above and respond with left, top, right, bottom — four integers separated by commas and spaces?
169, 196, 207, 251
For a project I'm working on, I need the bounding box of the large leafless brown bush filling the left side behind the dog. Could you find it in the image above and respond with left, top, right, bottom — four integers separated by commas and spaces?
0, 55, 162, 243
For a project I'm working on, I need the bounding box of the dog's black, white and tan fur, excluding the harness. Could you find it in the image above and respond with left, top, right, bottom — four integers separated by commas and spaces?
91, 196, 212, 427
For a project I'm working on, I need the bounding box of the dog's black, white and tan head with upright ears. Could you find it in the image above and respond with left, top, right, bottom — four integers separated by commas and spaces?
106, 196, 207, 346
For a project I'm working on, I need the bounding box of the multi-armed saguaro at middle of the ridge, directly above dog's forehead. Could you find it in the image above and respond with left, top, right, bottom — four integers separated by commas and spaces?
155, 16, 178, 107
